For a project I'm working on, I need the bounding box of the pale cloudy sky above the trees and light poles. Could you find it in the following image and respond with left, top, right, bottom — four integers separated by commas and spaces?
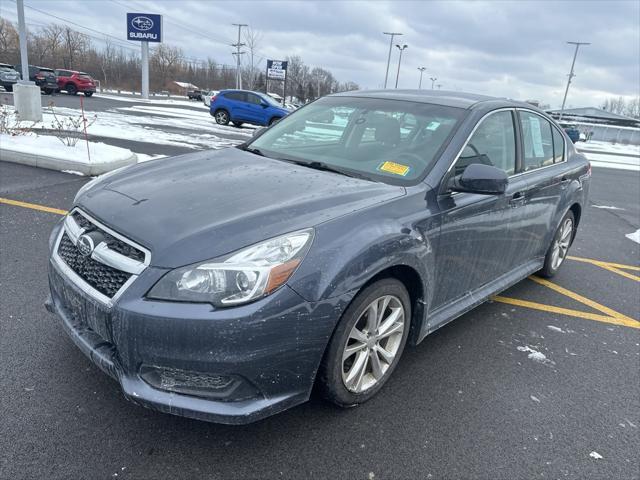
0, 0, 640, 108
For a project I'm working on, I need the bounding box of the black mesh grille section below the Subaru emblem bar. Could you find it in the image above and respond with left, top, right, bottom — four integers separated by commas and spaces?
58, 233, 131, 298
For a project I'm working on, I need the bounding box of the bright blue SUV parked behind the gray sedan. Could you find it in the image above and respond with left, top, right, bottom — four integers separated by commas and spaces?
209, 90, 289, 127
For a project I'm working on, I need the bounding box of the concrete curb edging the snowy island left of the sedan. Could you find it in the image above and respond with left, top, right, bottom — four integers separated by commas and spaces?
0, 147, 138, 177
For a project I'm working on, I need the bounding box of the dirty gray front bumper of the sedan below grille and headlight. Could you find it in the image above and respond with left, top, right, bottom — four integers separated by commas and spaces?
47, 248, 352, 424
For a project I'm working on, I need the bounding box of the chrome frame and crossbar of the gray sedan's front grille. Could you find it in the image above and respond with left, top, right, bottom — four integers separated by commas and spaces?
51, 207, 151, 309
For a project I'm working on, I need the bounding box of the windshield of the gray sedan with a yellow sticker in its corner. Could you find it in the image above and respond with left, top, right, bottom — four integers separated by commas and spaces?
246, 96, 465, 185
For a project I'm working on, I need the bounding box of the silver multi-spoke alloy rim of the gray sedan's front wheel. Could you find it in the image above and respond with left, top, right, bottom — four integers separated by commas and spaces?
342, 295, 405, 393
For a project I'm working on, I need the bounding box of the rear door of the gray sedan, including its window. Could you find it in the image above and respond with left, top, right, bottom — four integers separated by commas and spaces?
513, 109, 570, 263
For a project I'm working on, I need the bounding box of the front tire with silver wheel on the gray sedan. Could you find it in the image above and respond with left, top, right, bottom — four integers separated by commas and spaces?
317, 278, 411, 407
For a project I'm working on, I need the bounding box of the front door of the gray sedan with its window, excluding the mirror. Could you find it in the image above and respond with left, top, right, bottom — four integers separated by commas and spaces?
431, 109, 526, 311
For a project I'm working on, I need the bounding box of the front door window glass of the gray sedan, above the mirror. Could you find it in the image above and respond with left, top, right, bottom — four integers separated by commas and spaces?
454, 111, 516, 175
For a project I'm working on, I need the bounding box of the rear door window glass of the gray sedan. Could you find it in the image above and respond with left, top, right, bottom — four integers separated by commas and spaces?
520, 112, 554, 172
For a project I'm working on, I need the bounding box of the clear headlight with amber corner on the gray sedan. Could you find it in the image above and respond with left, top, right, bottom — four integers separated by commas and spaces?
147, 229, 313, 307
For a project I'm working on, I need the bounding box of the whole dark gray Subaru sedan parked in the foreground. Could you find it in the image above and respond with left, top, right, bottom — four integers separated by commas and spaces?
47, 90, 591, 423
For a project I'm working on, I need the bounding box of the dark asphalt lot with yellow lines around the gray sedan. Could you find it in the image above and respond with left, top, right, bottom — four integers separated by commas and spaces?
0, 162, 640, 480
